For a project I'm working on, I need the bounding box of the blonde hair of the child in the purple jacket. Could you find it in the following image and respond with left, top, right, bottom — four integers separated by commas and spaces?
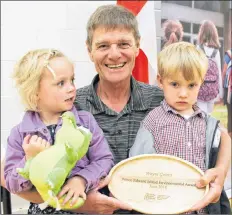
12, 49, 70, 111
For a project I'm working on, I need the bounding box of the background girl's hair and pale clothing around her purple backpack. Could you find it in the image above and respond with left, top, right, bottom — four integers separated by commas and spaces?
197, 20, 223, 114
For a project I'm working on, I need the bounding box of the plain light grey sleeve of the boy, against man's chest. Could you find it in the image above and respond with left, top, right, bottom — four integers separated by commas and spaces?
129, 124, 156, 157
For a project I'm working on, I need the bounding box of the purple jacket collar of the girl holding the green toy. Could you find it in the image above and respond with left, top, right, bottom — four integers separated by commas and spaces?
20, 106, 80, 132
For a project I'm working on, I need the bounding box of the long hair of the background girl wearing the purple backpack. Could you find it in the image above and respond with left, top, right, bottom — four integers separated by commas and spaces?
198, 20, 220, 49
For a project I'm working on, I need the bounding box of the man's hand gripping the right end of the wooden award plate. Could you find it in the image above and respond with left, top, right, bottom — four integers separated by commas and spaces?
190, 168, 225, 211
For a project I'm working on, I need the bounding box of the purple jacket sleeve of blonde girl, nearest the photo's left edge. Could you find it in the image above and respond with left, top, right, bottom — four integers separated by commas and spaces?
4, 126, 32, 193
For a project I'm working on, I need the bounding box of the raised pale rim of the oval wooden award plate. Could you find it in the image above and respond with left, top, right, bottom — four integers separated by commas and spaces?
108, 154, 209, 214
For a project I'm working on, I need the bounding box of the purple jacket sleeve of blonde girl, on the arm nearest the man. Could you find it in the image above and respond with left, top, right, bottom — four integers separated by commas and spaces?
69, 115, 114, 192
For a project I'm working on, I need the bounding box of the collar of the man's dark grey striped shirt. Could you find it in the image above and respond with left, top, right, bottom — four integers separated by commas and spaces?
87, 75, 148, 115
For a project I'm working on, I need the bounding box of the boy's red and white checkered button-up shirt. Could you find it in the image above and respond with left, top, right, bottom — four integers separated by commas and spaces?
142, 100, 206, 213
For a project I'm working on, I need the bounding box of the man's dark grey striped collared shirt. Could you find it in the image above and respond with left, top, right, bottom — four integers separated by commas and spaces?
75, 75, 163, 163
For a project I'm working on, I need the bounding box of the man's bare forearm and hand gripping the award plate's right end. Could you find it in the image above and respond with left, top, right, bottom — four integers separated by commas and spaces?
191, 130, 231, 211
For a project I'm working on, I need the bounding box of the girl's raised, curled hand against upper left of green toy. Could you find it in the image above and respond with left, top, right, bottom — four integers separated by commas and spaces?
22, 134, 50, 160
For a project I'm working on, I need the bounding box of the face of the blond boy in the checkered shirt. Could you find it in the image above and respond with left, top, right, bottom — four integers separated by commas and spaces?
158, 75, 201, 115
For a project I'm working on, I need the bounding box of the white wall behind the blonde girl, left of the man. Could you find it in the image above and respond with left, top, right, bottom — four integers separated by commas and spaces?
1, 1, 115, 213
